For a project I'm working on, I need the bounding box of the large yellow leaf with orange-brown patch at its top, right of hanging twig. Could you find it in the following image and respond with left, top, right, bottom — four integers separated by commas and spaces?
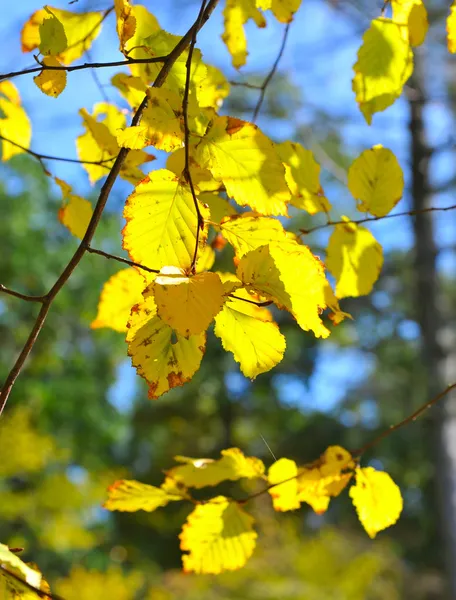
195, 117, 291, 215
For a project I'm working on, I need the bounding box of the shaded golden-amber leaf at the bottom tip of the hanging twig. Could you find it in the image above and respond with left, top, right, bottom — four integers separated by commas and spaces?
153, 267, 225, 337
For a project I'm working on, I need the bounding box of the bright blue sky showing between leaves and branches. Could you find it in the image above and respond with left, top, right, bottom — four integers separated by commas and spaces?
0, 0, 456, 420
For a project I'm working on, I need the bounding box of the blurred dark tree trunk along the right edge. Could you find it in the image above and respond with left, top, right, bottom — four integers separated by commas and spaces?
408, 52, 456, 600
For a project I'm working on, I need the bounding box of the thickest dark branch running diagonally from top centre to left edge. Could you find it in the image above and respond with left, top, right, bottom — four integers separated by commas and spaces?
0, 0, 218, 414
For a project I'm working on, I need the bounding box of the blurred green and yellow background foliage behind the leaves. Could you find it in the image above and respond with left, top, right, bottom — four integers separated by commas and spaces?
0, 2, 456, 600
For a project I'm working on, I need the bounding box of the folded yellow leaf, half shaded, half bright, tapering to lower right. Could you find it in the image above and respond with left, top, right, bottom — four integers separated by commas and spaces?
237, 240, 330, 338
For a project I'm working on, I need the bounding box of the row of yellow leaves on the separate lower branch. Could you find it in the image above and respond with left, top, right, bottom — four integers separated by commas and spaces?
104, 446, 402, 574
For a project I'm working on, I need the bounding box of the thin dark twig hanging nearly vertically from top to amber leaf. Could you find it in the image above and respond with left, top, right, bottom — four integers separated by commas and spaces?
182, 0, 206, 274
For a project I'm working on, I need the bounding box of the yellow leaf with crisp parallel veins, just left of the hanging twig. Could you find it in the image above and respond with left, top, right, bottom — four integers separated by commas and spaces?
122, 169, 209, 269
